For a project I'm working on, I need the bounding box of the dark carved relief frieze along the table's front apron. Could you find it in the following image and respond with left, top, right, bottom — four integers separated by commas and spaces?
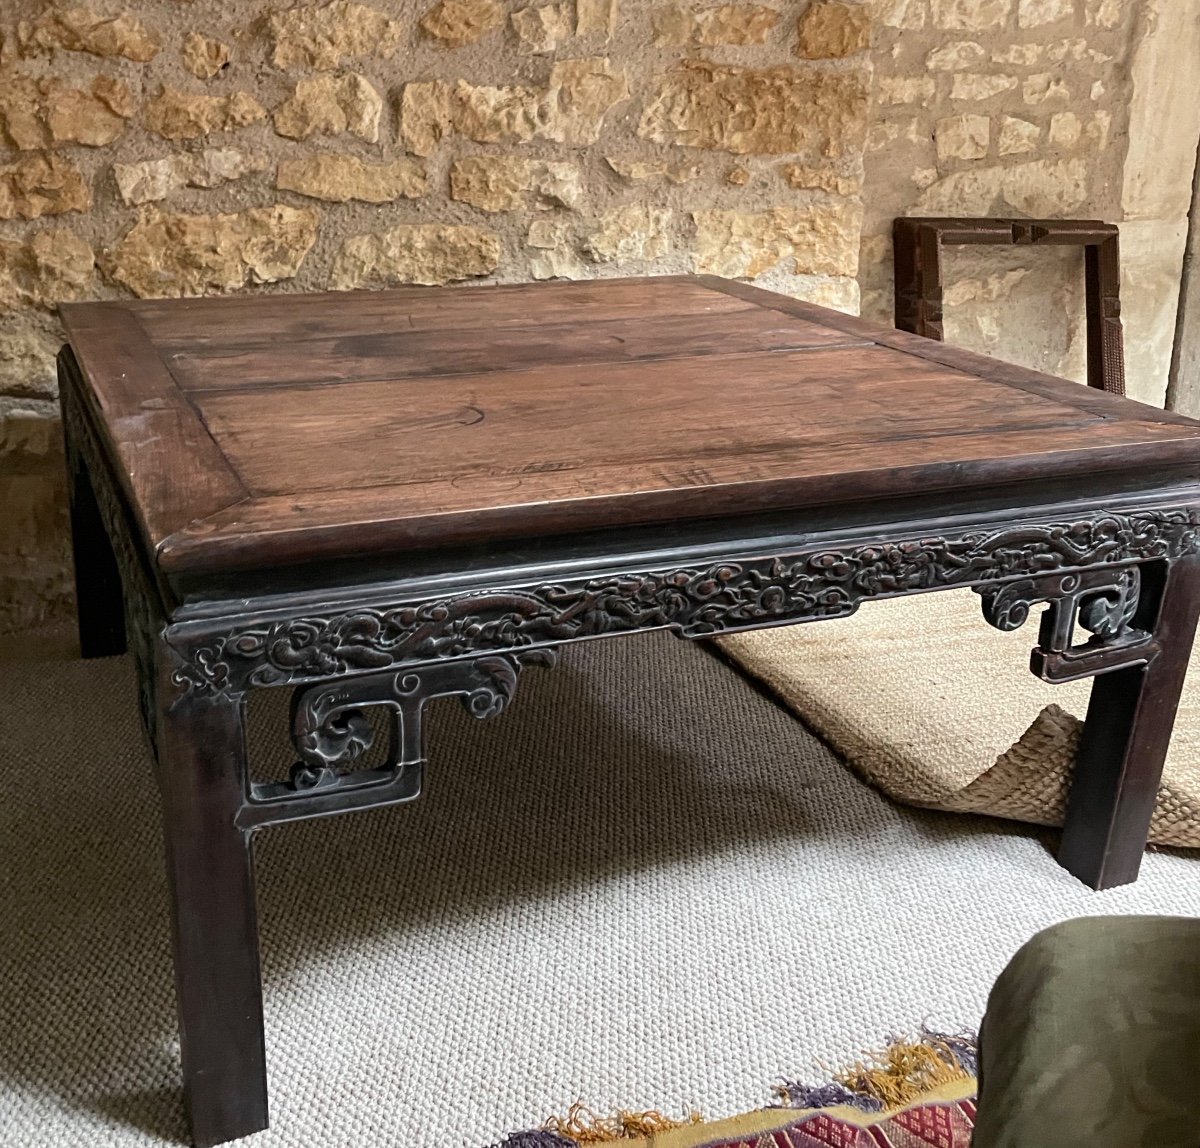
168, 509, 1200, 693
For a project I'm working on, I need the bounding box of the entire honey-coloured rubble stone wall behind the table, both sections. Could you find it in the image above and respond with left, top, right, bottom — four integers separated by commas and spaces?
0, 0, 1194, 631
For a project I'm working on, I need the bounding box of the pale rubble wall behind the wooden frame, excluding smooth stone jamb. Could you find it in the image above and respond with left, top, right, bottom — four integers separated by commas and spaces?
862, 0, 1128, 388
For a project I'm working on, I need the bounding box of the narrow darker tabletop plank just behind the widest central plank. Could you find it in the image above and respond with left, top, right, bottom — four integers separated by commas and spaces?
160, 307, 866, 393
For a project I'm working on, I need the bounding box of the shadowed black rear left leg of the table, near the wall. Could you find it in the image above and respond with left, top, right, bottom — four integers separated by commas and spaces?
67, 444, 125, 657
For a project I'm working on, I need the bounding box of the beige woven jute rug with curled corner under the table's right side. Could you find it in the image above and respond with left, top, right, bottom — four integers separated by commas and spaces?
720, 590, 1200, 848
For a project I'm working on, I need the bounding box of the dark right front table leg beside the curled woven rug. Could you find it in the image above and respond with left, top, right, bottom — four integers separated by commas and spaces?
1058, 557, 1200, 889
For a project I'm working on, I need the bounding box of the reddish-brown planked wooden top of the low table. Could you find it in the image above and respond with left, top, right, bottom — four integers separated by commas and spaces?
62, 269, 1200, 572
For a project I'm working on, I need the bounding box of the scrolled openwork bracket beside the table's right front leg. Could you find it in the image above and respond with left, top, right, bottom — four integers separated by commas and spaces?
976, 566, 1158, 683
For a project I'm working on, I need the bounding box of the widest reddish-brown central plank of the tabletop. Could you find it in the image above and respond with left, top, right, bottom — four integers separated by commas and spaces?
196, 347, 1094, 497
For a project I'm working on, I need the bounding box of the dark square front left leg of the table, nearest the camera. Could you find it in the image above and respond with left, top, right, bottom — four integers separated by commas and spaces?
157, 696, 268, 1148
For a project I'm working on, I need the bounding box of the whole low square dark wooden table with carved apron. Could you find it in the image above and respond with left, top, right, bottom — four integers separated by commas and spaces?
60, 278, 1200, 1144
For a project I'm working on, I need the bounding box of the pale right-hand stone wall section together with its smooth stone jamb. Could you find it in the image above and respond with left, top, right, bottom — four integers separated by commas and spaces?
860, 0, 1200, 409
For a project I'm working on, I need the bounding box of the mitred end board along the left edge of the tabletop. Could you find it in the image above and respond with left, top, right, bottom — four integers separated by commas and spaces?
60, 303, 247, 549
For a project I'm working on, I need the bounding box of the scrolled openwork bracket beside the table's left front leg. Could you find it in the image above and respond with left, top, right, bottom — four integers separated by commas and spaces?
239, 649, 557, 828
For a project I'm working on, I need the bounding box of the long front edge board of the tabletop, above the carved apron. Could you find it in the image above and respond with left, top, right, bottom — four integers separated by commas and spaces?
160, 422, 1200, 572
